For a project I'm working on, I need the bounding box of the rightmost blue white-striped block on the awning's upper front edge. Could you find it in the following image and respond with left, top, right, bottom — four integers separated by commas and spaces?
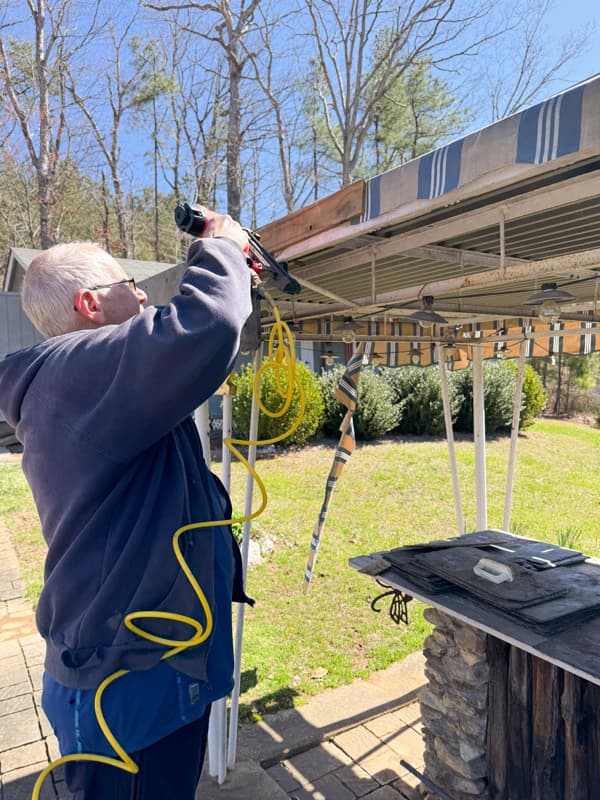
517, 86, 583, 164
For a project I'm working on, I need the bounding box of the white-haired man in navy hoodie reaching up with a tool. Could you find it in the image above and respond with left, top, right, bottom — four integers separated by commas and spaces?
0, 209, 251, 800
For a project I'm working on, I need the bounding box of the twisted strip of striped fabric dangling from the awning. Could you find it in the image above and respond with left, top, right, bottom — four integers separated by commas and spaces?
304, 342, 372, 594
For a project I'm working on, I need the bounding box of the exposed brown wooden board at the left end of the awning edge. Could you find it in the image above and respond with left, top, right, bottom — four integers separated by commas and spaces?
259, 181, 365, 253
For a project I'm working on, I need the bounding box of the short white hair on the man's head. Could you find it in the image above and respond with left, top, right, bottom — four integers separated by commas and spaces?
22, 242, 126, 336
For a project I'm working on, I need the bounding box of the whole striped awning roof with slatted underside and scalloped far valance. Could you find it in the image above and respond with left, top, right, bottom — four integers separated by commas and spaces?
261, 76, 600, 366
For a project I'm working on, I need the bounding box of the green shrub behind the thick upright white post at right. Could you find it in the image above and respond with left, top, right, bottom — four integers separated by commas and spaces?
452, 361, 516, 433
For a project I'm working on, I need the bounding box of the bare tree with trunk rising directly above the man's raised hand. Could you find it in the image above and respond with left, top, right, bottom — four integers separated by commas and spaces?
144, 0, 260, 220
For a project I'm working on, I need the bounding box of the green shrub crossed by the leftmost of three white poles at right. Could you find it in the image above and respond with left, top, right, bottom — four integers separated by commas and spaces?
382, 366, 462, 436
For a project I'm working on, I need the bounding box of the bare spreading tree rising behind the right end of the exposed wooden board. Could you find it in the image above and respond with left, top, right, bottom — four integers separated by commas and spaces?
306, 0, 494, 185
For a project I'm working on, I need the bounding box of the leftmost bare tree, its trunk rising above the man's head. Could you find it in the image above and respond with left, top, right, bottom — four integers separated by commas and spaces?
0, 0, 97, 248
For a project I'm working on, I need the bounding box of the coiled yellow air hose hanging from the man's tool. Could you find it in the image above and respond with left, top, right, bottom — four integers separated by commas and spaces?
31, 292, 306, 800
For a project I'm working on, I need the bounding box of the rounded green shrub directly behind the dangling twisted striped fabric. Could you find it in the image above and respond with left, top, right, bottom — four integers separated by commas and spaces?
321, 364, 402, 440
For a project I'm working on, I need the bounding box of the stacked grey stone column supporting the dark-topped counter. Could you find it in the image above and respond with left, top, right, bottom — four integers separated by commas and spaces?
420, 608, 489, 800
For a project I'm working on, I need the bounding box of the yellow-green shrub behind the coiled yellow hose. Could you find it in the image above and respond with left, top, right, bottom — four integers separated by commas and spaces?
233, 362, 324, 447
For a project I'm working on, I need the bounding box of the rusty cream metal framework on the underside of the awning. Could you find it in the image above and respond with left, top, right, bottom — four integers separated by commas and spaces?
264, 171, 600, 332
